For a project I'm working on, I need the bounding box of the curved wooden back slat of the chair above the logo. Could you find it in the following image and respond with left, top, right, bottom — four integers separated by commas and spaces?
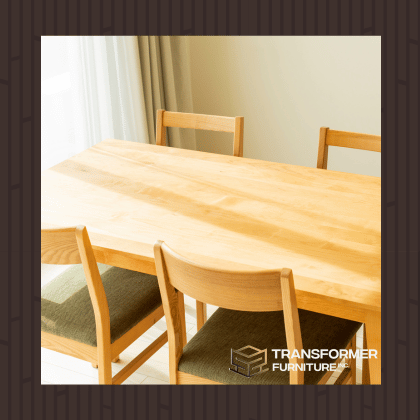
154, 240, 283, 312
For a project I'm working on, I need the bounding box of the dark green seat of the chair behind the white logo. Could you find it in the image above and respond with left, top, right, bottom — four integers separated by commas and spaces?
178, 308, 362, 385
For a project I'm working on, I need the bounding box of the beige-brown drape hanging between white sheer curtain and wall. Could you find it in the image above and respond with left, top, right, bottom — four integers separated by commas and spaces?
138, 36, 196, 150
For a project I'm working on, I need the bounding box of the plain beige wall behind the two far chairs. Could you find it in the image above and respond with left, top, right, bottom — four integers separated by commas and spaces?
189, 36, 381, 176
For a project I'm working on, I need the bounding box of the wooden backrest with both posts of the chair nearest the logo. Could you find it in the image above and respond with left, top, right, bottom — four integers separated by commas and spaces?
154, 241, 303, 383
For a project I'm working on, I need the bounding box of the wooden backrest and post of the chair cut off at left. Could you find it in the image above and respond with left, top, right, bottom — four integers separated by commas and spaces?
41, 226, 110, 352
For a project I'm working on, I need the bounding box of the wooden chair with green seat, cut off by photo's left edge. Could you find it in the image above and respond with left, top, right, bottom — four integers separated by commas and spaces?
41, 226, 168, 385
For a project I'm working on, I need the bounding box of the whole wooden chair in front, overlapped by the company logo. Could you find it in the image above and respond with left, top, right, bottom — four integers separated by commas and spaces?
154, 241, 361, 385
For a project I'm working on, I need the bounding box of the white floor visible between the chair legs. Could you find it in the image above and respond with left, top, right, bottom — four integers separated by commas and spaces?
41, 265, 363, 385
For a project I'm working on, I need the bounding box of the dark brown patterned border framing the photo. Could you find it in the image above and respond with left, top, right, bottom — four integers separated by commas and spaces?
0, 0, 420, 420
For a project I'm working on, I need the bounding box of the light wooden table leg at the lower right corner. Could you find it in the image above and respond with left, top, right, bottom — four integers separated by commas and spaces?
364, 312, 381, 385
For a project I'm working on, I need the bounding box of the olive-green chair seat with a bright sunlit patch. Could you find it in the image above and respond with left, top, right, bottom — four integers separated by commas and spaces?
41, 264, 162, 347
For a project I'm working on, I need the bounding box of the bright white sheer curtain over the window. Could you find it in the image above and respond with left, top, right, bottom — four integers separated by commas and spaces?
41, 36, 149, 170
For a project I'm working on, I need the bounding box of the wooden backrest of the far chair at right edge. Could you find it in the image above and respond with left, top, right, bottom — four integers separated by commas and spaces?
316, 127, 381, 169
